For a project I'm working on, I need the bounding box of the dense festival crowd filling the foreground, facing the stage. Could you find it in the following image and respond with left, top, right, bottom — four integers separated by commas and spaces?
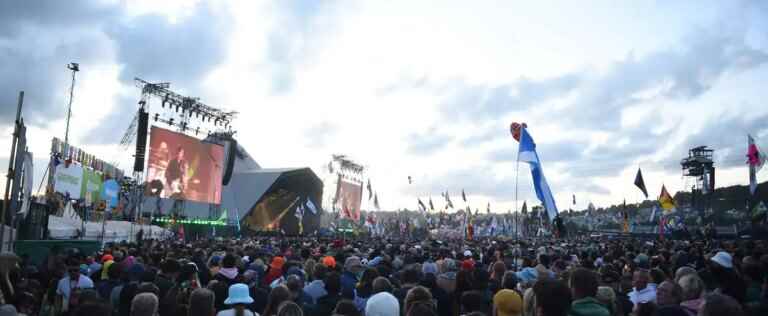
0, 237, 768, 316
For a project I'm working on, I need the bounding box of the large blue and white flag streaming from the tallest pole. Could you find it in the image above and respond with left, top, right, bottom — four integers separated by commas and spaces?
517, 128, 557, 219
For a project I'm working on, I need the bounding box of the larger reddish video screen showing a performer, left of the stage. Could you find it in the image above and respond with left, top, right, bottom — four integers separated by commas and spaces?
147, 126, 224, 204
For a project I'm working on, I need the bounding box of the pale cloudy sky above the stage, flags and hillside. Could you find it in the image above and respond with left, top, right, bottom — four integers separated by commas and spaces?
0, 0, 768, 212
